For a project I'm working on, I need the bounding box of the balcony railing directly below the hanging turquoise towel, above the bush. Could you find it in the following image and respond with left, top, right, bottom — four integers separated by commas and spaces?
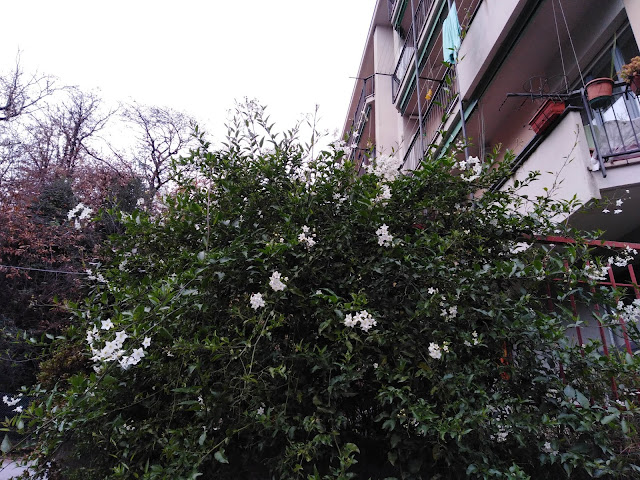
402, 68, 458, 170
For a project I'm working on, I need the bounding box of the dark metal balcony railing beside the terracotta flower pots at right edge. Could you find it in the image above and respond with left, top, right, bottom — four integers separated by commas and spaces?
588, 85, 640, 167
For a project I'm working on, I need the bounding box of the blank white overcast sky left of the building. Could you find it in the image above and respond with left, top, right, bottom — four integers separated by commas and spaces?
0, 0, 375, 144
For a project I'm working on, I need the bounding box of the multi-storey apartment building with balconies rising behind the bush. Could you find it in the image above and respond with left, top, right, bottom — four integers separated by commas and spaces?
343, 0, 640, 242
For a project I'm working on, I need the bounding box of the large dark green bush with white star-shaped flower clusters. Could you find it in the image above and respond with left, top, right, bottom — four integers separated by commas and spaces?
7, 104, 640, 480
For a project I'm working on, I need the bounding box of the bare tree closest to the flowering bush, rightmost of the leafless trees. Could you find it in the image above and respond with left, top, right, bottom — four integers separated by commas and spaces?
123, 102, 196, 196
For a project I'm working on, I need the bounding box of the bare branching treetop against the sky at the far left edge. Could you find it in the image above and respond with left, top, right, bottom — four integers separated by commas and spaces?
0, 52, 55, 122
